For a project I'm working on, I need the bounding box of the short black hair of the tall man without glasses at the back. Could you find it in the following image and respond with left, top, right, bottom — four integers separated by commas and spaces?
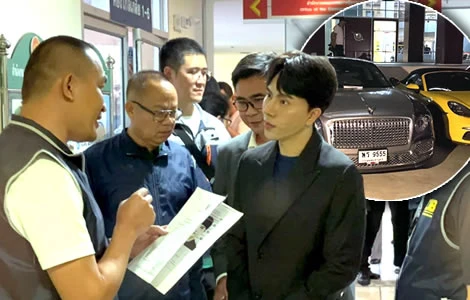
160, 38, 206, 72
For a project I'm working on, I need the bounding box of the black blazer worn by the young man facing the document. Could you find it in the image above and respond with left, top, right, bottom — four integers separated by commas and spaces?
220, 131, 366, 300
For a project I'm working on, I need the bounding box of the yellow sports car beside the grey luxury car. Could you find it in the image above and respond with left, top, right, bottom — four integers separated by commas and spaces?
406, 70, 470, 144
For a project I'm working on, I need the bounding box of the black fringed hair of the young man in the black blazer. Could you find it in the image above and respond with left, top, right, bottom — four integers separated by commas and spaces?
267, 51, 338, 113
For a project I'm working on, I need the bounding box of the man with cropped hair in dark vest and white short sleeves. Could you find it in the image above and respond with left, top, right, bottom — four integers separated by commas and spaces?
0, 36, 161, 300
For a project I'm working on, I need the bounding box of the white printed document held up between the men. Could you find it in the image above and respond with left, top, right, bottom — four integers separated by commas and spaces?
128, 188, 243, 294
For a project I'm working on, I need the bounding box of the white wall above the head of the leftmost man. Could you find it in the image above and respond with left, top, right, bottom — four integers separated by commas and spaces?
0, 0, 83, 55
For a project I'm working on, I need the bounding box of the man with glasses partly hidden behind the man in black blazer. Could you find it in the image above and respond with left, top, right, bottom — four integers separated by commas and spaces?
212, 53, 275, 300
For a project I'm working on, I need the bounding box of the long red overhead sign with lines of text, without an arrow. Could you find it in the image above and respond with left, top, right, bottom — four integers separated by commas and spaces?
271, 0, 364, 17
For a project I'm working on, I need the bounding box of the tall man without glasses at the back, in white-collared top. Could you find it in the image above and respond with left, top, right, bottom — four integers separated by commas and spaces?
160, 38, 231, 181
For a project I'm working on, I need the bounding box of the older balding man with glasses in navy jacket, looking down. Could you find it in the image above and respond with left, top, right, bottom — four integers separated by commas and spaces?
85, 71, 210, 300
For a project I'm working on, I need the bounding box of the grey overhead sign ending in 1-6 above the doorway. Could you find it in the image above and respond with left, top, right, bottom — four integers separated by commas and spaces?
109, 0, 152, 32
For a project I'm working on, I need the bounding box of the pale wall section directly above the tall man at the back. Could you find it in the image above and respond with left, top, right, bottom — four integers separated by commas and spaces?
168, 0, 203, 45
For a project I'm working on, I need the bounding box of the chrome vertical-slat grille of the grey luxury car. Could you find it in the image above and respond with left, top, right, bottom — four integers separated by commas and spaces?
329, 118, 411, 149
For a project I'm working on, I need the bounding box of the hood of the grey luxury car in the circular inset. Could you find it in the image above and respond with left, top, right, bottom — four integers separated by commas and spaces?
323, 88, 414, 119
